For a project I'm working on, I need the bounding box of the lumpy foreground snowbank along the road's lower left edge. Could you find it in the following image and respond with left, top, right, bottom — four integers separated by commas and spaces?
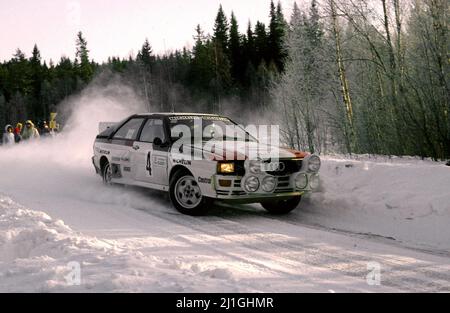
0, 195, 245, 292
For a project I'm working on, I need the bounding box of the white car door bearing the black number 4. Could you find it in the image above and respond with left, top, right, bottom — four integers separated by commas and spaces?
132, 117, 169, 186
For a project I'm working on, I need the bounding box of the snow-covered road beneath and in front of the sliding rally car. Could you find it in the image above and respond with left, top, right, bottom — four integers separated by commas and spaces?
0, 158, 450, 292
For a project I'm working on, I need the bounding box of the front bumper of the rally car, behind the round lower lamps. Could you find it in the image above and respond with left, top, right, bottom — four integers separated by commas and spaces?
212, 173, 319, 203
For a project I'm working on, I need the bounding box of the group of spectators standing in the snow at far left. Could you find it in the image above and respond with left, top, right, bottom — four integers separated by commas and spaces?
2, 120, 55, 146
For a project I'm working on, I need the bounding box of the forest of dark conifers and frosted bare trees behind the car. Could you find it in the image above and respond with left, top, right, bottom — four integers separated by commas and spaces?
0, 0, 450, 159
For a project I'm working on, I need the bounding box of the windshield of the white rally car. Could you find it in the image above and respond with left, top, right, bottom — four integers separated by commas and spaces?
169, 115, 258, 142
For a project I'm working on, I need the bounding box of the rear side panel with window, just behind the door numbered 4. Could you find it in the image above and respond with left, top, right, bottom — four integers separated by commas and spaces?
110, 117, 145, 183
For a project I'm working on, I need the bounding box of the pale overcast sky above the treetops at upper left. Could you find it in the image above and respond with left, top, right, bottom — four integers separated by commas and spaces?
0, 0, 307, 62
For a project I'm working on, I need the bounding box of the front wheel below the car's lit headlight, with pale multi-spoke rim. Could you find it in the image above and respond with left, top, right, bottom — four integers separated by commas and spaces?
169, 170, 212, 216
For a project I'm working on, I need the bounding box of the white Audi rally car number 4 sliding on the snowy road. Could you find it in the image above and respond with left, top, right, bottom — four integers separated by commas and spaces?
92, 113, 321, 215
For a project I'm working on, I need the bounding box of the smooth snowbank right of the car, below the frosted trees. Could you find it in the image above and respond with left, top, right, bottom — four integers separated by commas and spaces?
299, 156, 450, 251
